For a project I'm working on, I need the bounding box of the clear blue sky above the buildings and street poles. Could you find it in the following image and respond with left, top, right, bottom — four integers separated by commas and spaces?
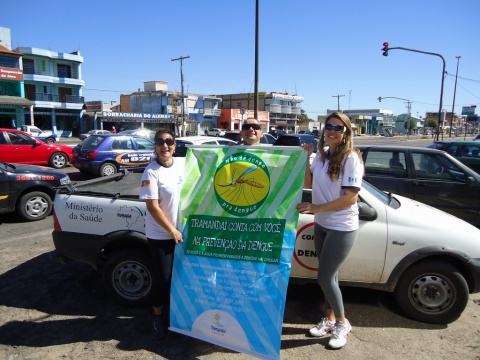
0, 0, 480, 119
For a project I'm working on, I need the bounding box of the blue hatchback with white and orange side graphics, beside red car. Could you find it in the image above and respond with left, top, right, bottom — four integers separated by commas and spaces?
72, 132, 155, 176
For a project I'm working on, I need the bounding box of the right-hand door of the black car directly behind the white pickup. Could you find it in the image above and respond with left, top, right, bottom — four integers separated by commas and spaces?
411, 151, 480, 223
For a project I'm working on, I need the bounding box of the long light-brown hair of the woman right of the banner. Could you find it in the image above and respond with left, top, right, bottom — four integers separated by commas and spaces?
318, 111, 363, 181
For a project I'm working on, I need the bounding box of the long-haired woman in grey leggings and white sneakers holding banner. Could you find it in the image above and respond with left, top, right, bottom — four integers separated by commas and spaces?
297, 112, 364, 349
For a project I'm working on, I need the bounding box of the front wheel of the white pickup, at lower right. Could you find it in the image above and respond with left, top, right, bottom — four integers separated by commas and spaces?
395, 261, 469, 324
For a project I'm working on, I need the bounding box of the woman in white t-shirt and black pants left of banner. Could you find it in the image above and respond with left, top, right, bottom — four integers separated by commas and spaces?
140, 128, 185, 339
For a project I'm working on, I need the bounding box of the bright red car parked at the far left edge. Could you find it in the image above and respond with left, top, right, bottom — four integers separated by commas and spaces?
0, 128, 73, 169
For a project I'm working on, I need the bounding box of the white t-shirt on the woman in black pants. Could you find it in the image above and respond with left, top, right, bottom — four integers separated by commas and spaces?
140, 157, 185, 240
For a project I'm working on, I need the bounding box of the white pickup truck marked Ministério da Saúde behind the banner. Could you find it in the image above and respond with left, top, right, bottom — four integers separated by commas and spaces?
52, 172, 480, 324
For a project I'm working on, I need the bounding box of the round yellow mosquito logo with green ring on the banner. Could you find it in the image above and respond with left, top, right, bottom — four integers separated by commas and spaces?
214, 152, 270, 216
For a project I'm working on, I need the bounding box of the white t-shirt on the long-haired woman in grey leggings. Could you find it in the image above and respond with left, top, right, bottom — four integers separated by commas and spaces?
310, 148, 364, 231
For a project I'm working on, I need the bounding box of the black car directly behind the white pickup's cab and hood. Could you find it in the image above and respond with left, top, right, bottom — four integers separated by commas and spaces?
358, 145, 480, 227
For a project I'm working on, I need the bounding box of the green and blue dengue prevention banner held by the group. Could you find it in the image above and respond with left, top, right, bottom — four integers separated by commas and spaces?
170, 146, 307, 359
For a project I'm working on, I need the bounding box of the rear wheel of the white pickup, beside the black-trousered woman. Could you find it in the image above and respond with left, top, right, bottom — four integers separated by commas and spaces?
103, 250, 152, 306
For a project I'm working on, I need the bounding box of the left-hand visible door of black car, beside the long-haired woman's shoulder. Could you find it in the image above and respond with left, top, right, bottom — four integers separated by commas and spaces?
363, 148, 415, 199
